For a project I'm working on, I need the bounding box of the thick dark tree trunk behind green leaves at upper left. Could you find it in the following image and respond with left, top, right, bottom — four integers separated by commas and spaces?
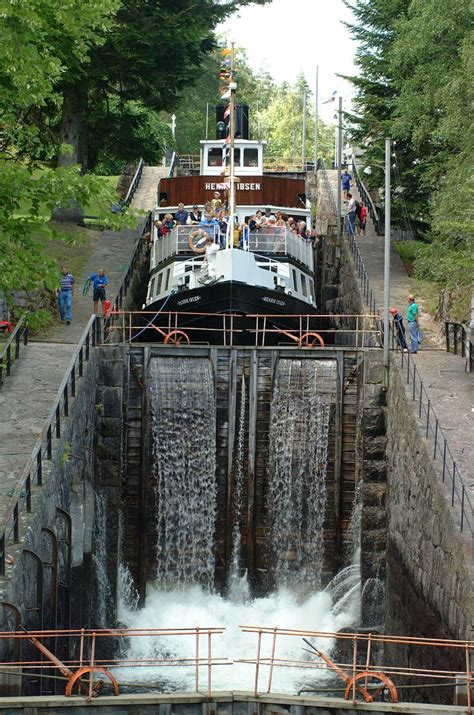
52, 82, 87, 223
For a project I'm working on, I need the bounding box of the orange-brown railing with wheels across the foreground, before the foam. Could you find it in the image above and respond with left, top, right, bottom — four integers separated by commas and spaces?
0, 626, 474, 713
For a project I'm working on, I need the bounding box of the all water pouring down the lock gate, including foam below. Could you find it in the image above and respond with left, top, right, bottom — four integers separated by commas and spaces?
119, 358, 354, 693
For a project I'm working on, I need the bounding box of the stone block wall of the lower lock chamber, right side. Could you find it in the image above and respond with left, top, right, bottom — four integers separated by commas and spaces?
386, 364, 474, 696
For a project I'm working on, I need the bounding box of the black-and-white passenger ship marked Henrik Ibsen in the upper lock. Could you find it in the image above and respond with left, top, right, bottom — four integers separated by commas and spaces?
141, 105, 321, 345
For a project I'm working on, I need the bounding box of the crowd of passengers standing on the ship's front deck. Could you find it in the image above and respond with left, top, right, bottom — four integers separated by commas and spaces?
149, 191, 315, 248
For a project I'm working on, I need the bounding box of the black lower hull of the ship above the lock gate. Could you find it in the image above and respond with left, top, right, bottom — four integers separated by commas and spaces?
132, 282, 326, 346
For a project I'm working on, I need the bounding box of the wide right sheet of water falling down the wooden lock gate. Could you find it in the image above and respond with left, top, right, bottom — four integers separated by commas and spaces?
269, 359, 336, 594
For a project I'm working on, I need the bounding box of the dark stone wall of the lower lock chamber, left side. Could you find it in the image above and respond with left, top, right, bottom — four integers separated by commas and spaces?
0, 350, 98, 693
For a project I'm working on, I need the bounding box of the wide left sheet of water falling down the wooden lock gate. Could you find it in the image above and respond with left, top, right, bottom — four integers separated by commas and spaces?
149, 357, 217, 591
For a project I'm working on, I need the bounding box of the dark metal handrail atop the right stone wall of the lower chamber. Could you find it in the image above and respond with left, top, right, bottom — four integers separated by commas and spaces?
397, 350, 474, 537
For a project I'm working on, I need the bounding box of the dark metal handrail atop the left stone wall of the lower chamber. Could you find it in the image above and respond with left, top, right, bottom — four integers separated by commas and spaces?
0, 315, 98, 576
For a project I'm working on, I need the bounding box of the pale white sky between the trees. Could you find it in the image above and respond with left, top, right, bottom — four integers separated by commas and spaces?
219, 0, 356, 121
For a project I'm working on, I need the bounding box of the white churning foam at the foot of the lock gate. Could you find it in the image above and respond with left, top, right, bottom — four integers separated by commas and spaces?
116, 585, 358, 693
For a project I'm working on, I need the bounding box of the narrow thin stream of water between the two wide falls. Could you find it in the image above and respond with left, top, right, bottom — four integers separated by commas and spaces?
227, 375, 250, 603
